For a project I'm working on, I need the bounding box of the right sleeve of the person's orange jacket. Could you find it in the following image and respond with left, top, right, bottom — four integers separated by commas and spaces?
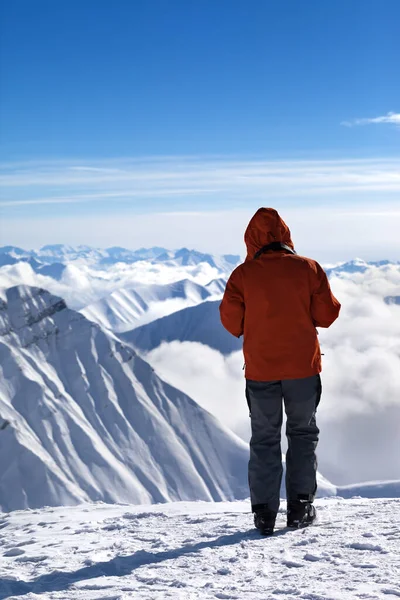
311, 263, 340, 327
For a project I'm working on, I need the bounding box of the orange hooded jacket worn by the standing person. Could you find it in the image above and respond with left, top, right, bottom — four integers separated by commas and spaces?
220, 208, 340, 381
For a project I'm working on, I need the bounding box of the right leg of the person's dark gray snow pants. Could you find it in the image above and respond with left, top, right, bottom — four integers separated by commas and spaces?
282, 375, 322, 503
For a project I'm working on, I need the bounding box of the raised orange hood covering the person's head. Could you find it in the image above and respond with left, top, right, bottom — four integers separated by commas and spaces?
244, 208, 294, 260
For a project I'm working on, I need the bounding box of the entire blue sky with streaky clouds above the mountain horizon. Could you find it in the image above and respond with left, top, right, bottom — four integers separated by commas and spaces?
0, 0, 400, 258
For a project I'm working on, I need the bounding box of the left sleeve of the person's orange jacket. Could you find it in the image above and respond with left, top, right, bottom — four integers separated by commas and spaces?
219, 269, 244, 337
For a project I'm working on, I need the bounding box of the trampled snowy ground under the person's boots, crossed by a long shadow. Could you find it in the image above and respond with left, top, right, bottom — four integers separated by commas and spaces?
0, 497, 400, 600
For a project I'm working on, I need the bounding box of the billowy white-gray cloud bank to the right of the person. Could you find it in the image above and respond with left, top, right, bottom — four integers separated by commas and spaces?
320, 267, 400, 483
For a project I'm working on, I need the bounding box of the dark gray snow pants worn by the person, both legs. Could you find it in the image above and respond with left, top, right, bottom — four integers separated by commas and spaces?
246, 375, 322, 512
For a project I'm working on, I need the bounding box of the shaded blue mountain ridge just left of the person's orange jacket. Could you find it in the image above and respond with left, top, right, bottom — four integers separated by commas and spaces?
120, 300, 242, 355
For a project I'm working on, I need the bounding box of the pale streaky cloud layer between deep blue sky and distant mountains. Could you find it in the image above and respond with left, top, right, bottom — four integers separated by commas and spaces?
0, 157, 400, 261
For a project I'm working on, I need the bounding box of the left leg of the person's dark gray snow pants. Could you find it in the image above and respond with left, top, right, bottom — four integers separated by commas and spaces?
246, 379, 283, 512
